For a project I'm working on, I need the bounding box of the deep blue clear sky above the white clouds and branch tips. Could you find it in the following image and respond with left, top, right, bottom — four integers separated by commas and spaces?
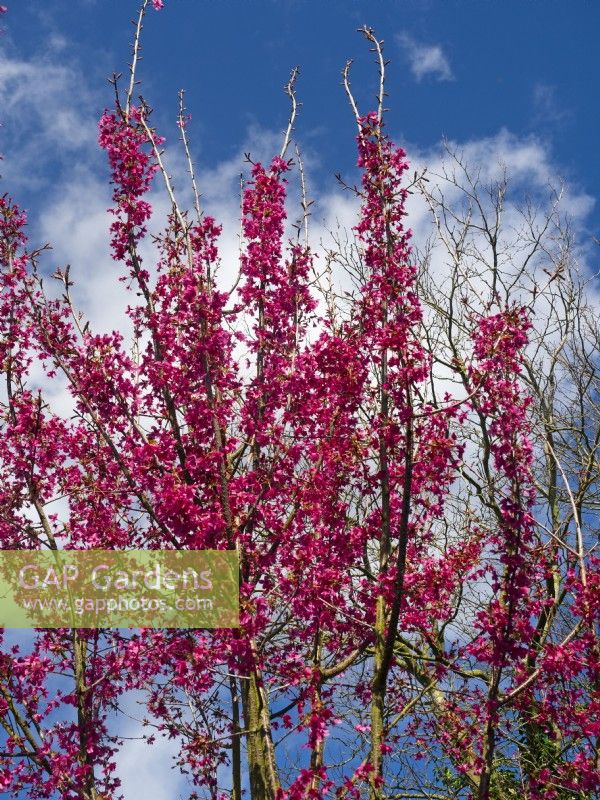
3, 0, 600, 236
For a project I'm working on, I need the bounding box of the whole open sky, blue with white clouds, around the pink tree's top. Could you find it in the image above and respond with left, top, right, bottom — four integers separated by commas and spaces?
0, 0, 600, 800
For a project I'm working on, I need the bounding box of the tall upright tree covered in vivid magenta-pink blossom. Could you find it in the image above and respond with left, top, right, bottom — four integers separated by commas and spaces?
0, 0, 600, 800
